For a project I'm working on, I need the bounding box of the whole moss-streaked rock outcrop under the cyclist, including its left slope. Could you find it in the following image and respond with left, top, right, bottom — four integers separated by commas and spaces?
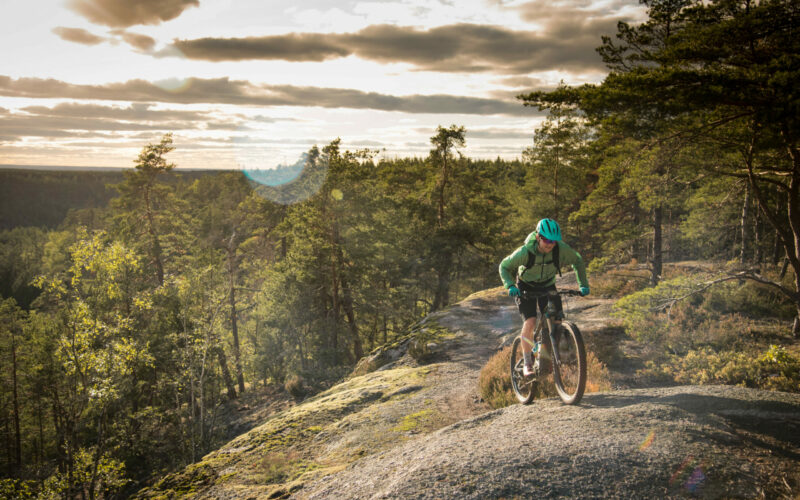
139, 289, 800, 499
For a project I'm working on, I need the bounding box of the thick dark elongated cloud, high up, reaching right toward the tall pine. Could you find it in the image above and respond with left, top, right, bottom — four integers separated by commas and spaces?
169, 22, 616, 74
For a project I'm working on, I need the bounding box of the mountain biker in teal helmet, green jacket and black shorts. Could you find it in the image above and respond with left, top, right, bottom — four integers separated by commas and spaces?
500, 219, 589, 377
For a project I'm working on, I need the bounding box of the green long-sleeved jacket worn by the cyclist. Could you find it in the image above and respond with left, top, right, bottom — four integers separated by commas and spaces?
500, 231, 589, 289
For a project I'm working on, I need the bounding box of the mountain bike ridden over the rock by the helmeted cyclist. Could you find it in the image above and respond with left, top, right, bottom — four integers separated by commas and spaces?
510, 290, 586, 405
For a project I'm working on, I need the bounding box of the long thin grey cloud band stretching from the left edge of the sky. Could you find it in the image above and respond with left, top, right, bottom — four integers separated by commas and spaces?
0, 75, 536, 116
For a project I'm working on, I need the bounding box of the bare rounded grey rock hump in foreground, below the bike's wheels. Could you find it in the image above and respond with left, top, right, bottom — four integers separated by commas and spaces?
297, 386, 800, 499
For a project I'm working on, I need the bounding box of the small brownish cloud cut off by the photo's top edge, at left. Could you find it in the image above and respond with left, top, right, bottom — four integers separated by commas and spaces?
67, 0, 200, 28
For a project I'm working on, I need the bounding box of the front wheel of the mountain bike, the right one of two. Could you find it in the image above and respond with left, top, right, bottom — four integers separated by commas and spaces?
553, 321, 586, 405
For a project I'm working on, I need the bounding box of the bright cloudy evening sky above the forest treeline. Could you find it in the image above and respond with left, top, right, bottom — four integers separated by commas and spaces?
0, 0, 644, 169
